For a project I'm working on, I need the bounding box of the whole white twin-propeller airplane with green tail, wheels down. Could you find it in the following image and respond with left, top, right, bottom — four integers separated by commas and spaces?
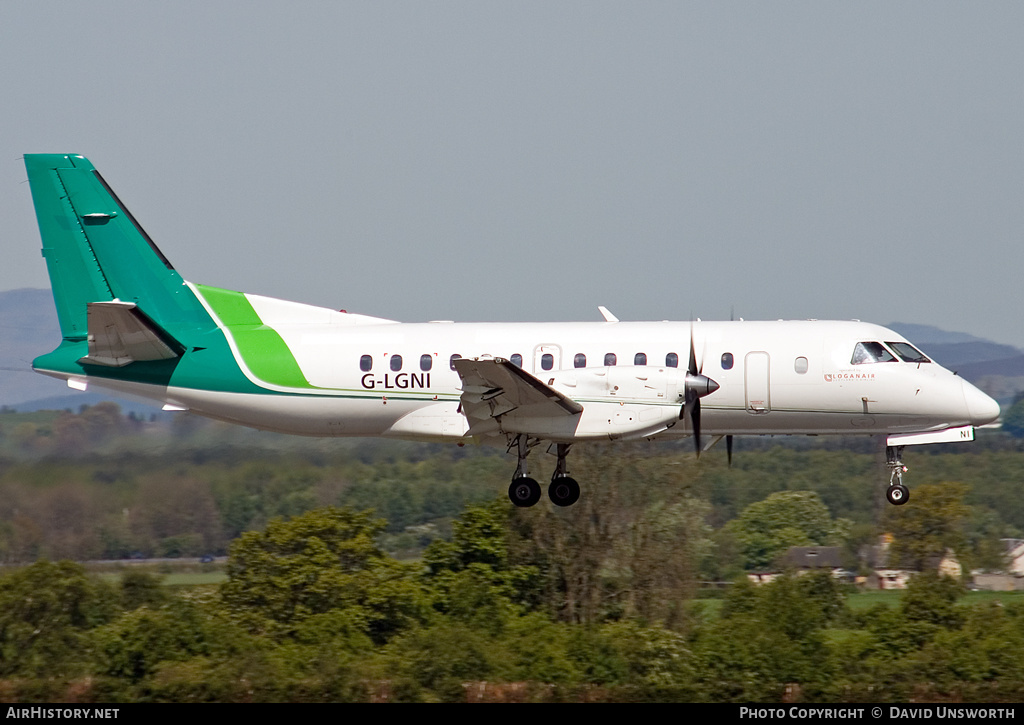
25, 154, 999, 506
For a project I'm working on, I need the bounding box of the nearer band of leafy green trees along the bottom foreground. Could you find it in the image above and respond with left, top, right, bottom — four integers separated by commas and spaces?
0, 503, 1024, 702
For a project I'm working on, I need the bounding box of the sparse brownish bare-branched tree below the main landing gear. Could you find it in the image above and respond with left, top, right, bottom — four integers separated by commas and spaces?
510, 443, 710, 628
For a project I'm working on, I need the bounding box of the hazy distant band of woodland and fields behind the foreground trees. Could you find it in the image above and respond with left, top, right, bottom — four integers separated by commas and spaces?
0, 403, 1024, 577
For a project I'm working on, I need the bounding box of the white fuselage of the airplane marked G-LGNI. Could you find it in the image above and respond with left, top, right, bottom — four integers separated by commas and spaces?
90, 309, 998, 442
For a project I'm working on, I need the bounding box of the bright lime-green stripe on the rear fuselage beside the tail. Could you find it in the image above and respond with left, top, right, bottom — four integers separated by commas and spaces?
196, 285, 314, 389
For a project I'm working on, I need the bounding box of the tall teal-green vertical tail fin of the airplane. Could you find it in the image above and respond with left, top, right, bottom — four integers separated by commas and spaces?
25, 154, 211, 340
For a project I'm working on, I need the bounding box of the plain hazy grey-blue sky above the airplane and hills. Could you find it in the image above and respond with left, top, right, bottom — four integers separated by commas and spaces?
0, 0, 1024, 346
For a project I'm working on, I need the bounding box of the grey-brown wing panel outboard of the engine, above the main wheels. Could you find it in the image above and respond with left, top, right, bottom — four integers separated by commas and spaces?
452, 357, 583, 435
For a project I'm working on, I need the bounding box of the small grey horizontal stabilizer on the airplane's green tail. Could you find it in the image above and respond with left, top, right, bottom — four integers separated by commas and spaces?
79, 300, 184, 368
